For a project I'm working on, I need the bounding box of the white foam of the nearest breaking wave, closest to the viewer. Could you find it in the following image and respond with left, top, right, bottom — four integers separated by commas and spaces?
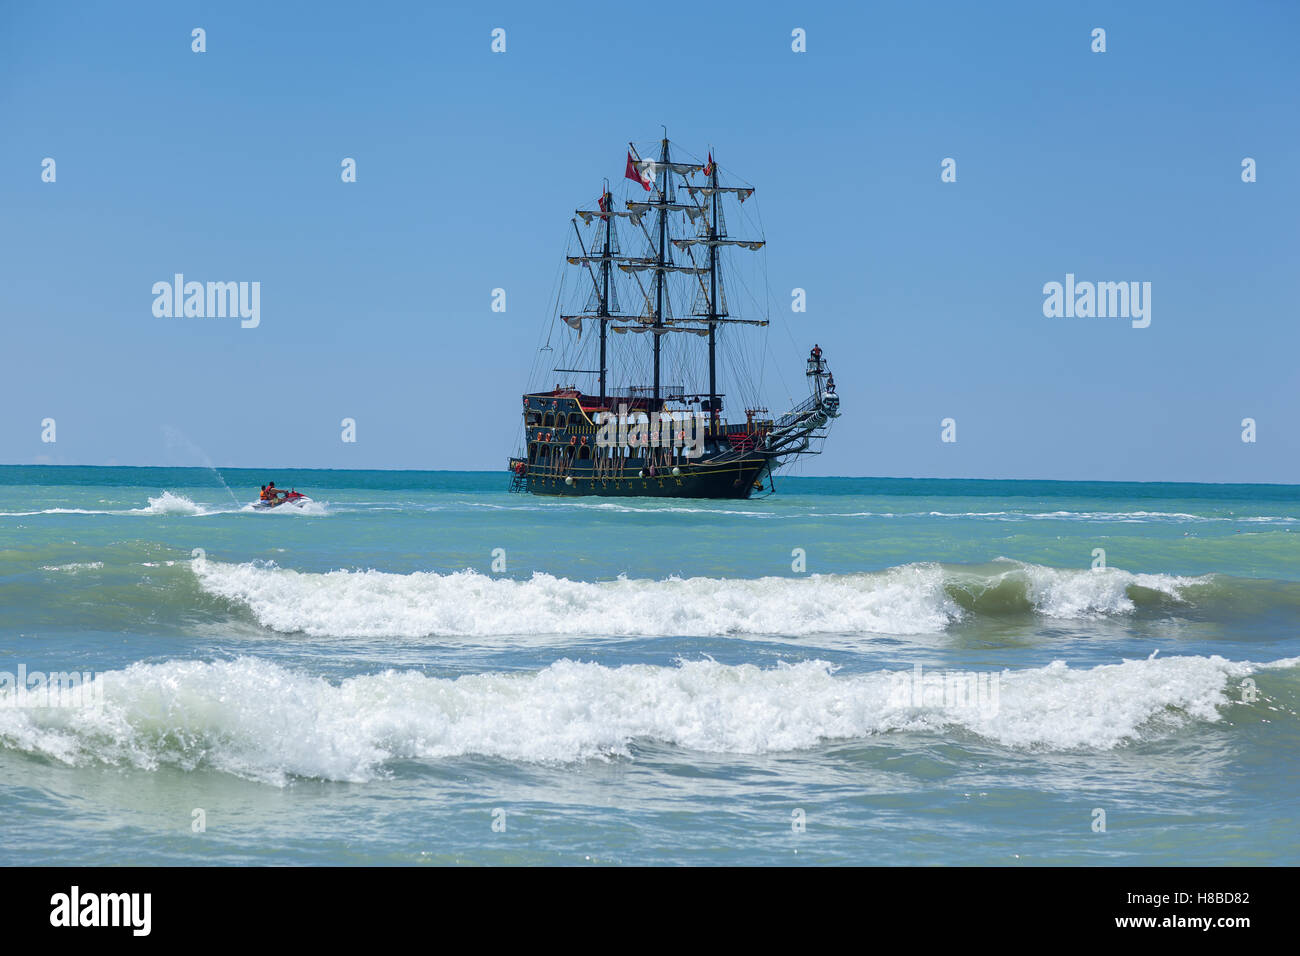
0, 657, 1300, 784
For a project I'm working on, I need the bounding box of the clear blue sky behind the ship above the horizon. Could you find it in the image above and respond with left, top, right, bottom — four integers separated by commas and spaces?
0, 3, 1300, 483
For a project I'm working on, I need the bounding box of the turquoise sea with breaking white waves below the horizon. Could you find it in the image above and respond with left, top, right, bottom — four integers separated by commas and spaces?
0, 466, 1300, 865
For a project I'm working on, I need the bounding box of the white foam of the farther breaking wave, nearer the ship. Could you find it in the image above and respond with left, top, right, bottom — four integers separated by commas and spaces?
192, 561, 1208, 637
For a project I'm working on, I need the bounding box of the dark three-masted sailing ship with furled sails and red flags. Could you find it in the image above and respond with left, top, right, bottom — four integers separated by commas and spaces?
508, 131, 840, 498
